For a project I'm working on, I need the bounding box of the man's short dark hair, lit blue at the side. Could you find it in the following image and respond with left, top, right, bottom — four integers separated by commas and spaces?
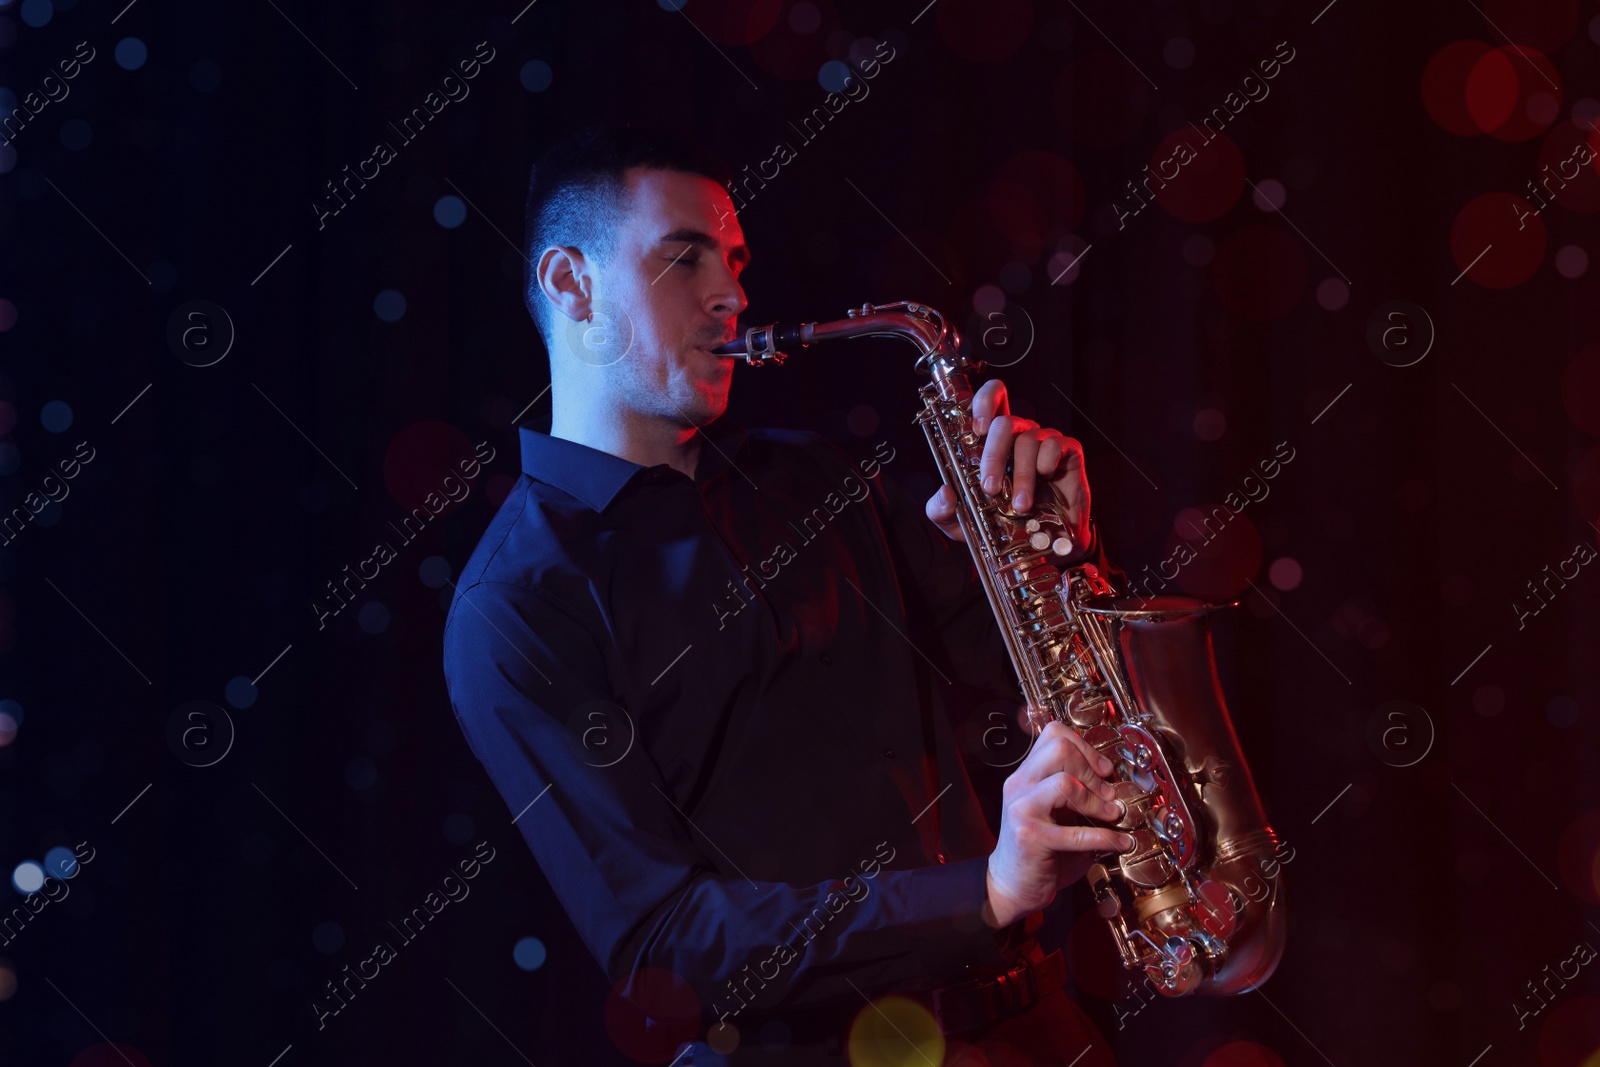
523, 123, 733, 346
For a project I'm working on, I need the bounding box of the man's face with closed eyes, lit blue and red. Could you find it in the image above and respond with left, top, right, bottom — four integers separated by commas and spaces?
594, 168, 750, 427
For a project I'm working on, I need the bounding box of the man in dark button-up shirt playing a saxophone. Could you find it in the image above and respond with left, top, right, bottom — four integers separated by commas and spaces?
445, 120, 1131, 1067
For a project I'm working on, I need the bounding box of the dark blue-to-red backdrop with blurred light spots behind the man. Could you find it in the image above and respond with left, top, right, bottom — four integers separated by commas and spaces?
0, 0, 1600, 1067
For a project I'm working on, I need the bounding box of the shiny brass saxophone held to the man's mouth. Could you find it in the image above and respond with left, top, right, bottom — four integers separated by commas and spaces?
715, 301, 1288, 997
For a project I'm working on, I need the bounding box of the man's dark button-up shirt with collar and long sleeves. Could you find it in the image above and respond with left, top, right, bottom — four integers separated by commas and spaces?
445, 418, 1075, 1027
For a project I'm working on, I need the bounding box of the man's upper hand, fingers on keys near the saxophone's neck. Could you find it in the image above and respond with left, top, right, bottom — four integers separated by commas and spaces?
926, 378, 1090, 558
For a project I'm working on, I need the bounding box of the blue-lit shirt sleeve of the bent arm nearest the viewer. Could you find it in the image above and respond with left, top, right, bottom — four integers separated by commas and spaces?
445, 582, 1003, 1021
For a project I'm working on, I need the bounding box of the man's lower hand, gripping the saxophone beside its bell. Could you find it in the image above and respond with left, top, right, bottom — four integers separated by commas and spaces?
984, 720, 1133, 929
